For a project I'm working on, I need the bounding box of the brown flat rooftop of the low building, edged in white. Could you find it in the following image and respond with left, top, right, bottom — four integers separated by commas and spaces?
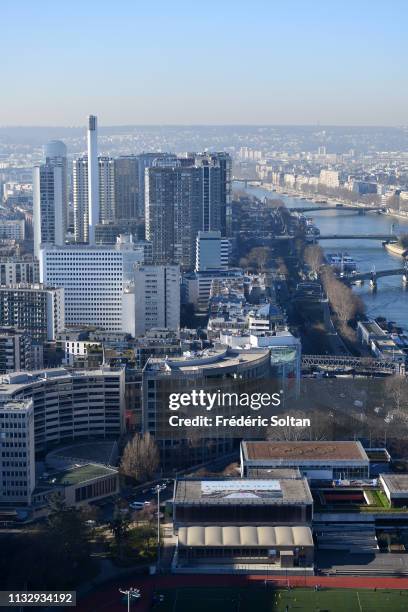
242, 440, 368, 463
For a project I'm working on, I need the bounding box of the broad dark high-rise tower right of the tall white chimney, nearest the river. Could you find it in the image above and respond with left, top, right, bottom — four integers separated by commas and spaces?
145, 153, 230, 269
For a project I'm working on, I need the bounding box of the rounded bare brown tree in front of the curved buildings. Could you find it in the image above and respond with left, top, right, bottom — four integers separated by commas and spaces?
120, 433, 160, 482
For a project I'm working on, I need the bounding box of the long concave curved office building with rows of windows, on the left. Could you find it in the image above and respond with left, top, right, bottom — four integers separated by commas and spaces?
0, 367, 125, 452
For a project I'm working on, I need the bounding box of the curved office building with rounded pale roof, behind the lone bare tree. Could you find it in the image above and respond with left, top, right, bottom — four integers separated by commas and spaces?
142, 346, 270, 468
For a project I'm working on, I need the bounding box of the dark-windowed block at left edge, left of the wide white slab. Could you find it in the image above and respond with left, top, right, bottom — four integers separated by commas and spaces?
0, 284, 65, 342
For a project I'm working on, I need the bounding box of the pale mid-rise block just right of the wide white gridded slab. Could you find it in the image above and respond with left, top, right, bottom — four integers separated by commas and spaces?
126, 265, 180, 336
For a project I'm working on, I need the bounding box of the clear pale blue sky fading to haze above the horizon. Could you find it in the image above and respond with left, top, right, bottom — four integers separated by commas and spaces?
0, 0, 408, 126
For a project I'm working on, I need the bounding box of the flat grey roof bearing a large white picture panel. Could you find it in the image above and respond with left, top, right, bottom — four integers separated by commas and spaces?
174, 478, 313, 506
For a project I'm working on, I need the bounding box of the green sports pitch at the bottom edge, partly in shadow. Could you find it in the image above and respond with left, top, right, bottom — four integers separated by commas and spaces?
151, 586, 408, 612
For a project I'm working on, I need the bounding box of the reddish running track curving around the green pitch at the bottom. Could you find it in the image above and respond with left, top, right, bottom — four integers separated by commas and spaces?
76, 574, 408, 612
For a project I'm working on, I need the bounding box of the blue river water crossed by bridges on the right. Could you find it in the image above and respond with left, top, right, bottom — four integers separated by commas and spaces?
237, 184, 408, 330
